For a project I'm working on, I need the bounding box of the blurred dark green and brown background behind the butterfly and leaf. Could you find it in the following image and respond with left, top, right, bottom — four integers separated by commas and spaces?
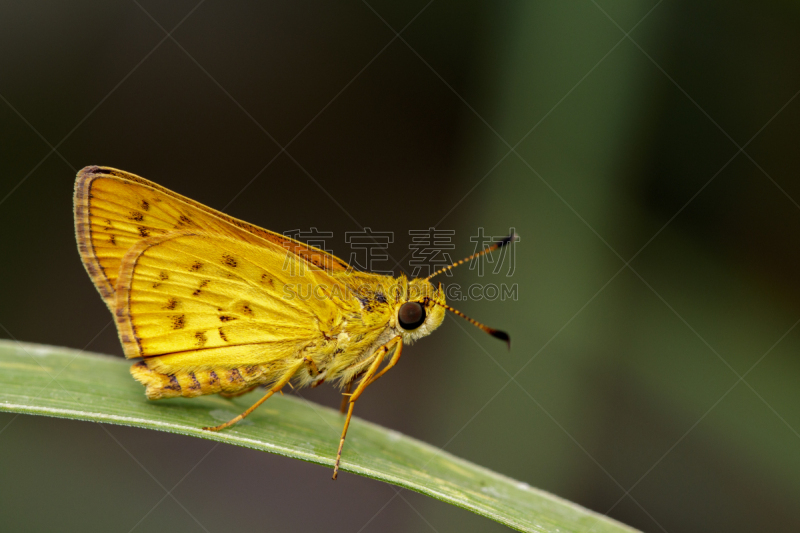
0, 0, 800, 532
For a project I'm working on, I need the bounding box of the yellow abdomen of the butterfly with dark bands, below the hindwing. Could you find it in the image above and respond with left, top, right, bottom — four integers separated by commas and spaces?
131, 361, 271, 400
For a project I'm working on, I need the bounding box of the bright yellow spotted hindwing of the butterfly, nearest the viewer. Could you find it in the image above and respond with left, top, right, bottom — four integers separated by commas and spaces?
115, 230, 347, 374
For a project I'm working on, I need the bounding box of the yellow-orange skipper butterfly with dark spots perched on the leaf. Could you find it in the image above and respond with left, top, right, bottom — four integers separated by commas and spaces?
74, 166, 515, 479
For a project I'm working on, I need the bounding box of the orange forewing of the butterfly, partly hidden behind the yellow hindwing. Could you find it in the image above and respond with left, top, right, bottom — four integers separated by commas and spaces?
75, 166, 350, 311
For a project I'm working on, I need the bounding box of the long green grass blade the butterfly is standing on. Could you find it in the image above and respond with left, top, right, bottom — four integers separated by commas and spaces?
0, 341, 634, 533
